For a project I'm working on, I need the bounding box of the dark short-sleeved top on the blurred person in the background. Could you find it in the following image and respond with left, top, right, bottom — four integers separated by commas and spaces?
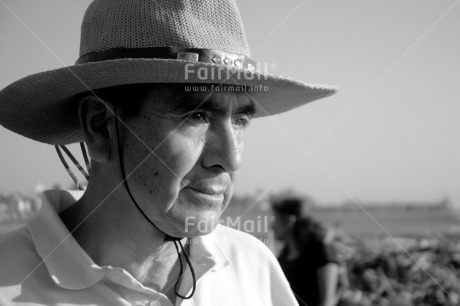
278, 242, 339, 306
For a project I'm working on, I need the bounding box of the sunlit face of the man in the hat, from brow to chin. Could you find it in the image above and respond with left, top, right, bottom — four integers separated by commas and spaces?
123, 87, 255, 237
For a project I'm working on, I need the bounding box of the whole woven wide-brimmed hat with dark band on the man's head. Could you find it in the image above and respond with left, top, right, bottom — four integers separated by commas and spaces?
0, 0, 335, 144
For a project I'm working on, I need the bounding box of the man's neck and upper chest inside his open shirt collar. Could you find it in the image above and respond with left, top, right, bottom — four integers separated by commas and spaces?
60, 180, 184, 298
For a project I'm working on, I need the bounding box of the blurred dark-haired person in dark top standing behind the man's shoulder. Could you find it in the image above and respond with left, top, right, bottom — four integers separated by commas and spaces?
272, 198, 340, 306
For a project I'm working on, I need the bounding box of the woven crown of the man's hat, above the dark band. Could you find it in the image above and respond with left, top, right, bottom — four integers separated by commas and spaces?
80, 0, 250, 56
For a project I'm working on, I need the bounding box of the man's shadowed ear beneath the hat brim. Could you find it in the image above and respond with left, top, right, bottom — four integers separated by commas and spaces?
78, 95, 115, 163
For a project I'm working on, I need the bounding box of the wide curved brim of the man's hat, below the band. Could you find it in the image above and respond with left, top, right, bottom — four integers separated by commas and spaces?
0, 59, 336, 145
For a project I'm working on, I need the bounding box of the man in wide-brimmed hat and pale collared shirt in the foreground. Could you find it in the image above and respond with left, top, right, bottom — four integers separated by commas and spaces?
0, 0, 334, 306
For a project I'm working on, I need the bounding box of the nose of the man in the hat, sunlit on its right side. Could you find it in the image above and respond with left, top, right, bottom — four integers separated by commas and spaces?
203, 123, 244, 173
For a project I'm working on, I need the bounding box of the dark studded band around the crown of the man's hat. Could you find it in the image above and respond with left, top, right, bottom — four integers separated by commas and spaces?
76, 47, 257, 71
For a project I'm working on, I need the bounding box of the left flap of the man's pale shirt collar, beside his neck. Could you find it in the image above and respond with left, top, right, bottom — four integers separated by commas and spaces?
28, 190, 107, 290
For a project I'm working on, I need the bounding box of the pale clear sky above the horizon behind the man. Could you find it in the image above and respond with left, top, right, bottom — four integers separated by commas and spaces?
0, 0, 460, 207
